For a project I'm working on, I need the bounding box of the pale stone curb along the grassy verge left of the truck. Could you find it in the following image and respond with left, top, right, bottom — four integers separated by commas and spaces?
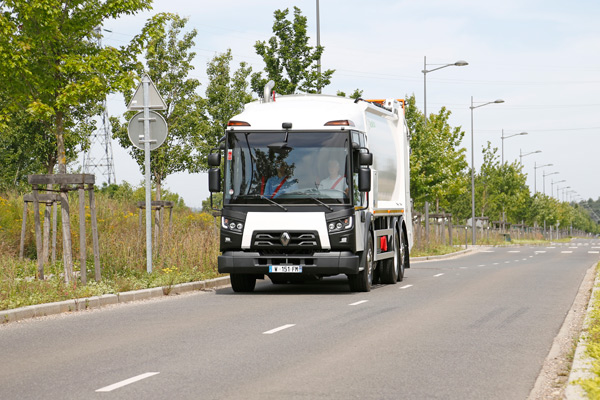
0, 276, 231, 323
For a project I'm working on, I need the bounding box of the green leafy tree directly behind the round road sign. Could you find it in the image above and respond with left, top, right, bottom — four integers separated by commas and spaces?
111, 14, 203, 200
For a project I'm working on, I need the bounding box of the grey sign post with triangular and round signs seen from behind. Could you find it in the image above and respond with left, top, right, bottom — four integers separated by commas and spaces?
127, 74, 167, 274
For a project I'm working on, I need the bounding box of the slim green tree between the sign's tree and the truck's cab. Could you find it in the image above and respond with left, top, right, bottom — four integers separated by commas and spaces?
196, 49, 252, 170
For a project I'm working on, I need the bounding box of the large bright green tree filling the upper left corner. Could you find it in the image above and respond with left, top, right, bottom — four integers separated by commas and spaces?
0, 0, 151, 173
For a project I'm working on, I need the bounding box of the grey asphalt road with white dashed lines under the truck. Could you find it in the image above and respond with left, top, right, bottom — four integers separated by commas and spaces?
0, 240, 600, 400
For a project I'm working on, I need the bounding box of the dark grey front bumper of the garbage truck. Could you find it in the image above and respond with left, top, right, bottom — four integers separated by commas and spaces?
218, 251, 359, 275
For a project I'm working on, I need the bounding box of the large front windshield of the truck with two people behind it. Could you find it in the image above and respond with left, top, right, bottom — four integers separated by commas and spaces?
224, 131, 352, 205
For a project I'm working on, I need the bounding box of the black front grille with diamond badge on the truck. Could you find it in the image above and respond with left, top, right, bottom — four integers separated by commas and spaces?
252, 231, 321, 252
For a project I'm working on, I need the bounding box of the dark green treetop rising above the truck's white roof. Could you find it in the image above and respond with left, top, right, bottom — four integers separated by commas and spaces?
252, 7, 335, 96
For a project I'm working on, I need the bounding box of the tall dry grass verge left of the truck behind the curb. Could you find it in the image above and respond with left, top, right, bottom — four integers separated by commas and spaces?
0, 194, 219, 310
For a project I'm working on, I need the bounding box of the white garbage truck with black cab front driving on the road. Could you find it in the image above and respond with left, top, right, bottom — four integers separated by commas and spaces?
208, 95, 413, 292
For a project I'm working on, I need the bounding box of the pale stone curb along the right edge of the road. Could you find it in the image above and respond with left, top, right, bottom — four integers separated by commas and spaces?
565, 263, 600, 400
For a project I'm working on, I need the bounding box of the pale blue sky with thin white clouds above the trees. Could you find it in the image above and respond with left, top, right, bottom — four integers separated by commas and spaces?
88, 0, 600, 207
